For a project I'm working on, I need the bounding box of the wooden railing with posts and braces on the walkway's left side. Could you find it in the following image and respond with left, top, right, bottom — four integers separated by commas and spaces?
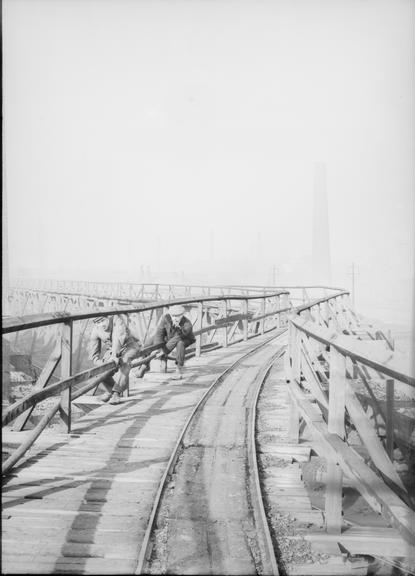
2, 291, 290, 473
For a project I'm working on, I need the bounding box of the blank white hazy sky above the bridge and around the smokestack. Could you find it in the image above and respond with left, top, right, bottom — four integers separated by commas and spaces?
3, 0, 415, 325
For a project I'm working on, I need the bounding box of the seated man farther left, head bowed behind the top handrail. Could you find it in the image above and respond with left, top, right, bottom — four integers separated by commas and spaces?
90, 315, 141, 404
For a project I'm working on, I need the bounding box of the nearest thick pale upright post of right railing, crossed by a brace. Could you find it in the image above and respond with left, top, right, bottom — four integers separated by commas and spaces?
325, 346, 346, 534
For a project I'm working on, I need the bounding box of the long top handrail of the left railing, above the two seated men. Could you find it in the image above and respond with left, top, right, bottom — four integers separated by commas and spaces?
2, 291, 288, 334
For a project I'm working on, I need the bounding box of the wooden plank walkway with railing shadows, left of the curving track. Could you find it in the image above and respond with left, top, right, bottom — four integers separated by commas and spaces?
2, 335, 278, 574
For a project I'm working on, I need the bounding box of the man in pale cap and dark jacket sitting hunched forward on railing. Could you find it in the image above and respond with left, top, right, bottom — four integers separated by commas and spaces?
137, 304, 196, 380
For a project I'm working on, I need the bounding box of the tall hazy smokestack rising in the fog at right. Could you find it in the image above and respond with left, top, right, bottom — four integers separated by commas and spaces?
313, 162, 331, 285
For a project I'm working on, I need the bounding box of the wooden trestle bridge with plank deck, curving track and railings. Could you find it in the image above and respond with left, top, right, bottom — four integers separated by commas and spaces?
2, 282, 415, 575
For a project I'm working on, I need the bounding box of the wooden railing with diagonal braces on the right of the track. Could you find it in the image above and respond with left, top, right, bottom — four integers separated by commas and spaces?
286, 296, 415, 542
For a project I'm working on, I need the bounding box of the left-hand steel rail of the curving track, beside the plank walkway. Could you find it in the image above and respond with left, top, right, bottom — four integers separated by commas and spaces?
134, 328, 287, 574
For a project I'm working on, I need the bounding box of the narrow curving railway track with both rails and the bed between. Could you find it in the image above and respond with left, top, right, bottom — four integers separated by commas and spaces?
136, 332, 286, 574
